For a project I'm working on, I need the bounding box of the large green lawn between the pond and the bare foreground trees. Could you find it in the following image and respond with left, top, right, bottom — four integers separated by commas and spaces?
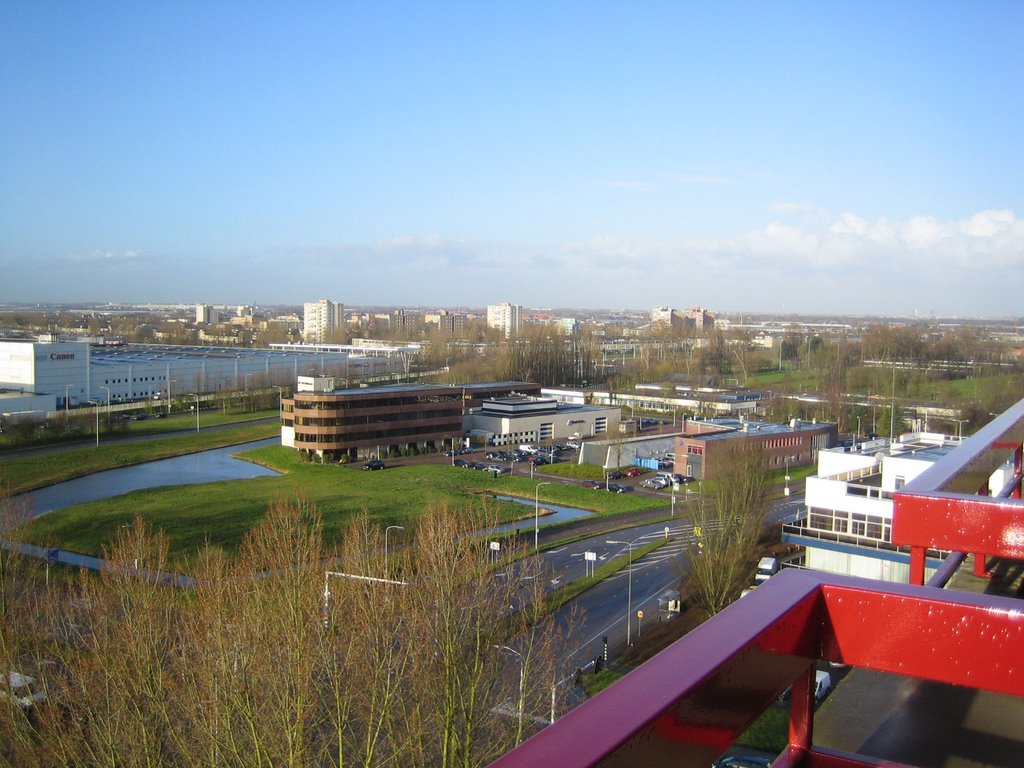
17, 445, 665, 557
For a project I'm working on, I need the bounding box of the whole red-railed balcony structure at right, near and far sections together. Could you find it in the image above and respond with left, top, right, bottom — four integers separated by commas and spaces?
485, 401, 1024, 768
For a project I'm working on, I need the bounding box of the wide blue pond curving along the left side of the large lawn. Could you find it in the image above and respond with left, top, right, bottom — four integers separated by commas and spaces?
27, 437, 281, 516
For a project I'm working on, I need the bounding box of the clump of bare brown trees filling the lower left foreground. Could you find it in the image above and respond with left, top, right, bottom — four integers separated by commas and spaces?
0, 500, 565, 768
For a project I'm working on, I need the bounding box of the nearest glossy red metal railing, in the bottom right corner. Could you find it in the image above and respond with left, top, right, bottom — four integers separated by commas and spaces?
493, 569, 1024, 768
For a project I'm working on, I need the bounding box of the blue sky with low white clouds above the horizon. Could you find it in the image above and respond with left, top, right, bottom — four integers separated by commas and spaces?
0, 0, 1024, 315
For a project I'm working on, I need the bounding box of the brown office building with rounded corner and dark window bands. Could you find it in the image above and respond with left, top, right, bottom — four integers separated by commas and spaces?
281, 377, 541, 461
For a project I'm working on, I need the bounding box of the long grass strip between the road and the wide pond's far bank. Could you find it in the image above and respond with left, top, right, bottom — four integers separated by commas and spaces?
0, 422, 281, 494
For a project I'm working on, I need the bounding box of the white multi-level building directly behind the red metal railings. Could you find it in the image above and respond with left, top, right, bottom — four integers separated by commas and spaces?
782, 432, 978, 583
